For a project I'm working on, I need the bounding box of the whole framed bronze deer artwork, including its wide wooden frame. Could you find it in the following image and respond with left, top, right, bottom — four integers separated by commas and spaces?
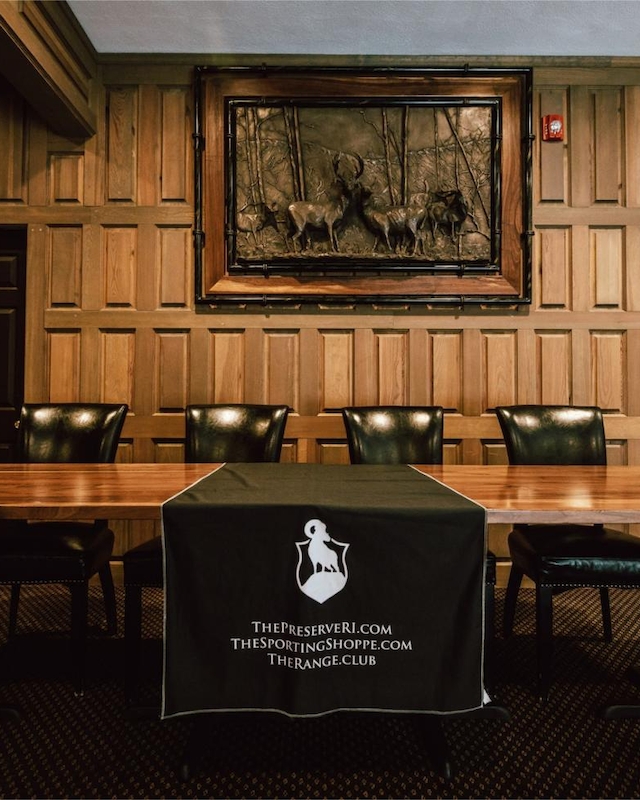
194, 67, 533, 305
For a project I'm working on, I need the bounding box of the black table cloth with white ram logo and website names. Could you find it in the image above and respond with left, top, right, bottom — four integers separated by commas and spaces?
162, 464, 486, 718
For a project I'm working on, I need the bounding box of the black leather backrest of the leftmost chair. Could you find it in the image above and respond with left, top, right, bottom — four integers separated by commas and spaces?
17, 403, 128, 464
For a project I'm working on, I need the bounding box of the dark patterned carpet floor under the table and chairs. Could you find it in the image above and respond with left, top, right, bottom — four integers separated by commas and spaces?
0, 587, 640, 798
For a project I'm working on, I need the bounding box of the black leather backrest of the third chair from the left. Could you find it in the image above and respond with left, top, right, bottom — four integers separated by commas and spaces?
342, 406, 443, 464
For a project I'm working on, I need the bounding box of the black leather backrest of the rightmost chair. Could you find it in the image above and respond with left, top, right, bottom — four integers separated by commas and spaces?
496, 405, 607, 465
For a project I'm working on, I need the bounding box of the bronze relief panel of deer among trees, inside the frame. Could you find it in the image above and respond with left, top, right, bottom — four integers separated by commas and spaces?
230, 105, 494, 267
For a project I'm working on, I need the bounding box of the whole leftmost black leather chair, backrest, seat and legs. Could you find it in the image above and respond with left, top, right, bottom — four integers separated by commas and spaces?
0, 403, 128, 693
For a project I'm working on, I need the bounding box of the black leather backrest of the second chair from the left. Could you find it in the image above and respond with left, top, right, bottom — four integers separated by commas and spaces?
185, 403, 289, 463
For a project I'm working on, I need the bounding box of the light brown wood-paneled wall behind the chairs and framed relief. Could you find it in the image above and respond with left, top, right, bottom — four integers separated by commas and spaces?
0, 61, 640, 568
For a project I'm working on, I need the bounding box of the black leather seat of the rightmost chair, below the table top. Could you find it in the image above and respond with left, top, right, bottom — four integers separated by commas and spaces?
509, 525, 640, 586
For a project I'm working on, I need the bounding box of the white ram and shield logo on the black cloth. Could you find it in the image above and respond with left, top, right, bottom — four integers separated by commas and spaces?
296, 519, 349, 603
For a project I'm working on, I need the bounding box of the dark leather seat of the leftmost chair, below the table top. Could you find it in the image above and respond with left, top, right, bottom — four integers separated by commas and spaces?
0, 522, 114, 583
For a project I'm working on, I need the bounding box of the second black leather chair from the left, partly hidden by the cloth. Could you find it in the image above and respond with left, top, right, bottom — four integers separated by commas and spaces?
123, 404, 289, 705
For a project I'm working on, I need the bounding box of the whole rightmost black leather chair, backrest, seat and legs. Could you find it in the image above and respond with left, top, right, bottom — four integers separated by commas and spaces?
496, 405, 640, 699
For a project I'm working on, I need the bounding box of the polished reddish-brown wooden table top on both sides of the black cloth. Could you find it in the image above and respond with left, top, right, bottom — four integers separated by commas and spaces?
0, 464, 640, 523
